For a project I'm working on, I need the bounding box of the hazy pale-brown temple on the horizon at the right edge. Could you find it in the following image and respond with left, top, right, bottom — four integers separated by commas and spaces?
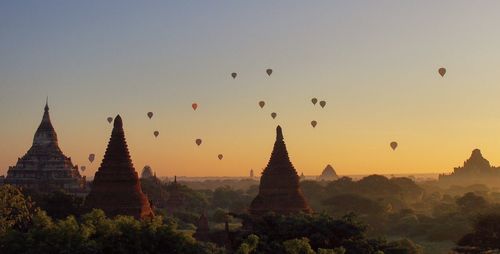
439, 149, 500, 184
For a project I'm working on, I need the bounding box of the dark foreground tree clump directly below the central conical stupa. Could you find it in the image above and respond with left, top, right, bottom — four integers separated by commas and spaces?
230, 214, 421, 254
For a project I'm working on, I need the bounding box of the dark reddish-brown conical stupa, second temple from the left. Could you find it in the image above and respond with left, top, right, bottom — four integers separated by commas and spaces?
85, 115, 153, 219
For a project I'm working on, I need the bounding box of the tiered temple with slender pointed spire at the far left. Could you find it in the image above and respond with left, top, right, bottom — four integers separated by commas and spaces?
4, 100, 86, 196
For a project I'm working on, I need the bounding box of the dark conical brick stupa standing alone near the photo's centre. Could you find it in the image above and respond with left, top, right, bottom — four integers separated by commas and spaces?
249, 126, 312, 215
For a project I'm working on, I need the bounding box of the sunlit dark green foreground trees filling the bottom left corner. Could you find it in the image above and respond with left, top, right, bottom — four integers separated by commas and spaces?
0, 185, 225, 254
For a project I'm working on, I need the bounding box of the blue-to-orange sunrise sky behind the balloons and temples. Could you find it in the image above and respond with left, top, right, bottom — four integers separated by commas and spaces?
0, 0, 500, 177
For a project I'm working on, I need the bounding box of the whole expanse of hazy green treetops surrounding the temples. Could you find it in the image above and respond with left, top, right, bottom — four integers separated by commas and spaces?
0, 175, 500, 253
